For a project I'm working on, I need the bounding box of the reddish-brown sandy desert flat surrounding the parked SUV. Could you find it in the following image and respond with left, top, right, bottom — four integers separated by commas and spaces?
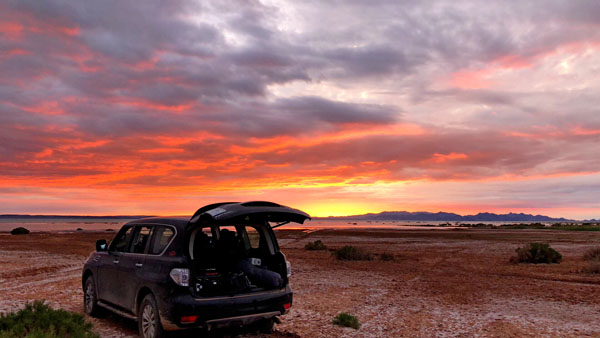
0, 229, 600, 337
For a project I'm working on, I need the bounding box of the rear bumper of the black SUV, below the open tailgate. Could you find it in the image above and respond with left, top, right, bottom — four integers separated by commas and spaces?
159, 286, 293, 331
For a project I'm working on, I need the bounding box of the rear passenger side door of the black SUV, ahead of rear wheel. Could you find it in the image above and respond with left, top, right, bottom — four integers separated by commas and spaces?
117, 225, 153, 311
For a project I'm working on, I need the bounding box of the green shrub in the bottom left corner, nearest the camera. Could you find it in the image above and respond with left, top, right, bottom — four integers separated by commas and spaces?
0, 300, 98, 338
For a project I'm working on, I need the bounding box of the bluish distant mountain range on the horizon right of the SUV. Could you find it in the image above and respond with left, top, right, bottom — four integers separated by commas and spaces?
321, 211, 573, 222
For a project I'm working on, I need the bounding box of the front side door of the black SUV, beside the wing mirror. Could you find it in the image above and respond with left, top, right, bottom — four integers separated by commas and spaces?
96, 226, 133, 304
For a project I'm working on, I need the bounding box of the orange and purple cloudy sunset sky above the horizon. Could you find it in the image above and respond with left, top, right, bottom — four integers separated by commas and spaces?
0, 0, 600, 219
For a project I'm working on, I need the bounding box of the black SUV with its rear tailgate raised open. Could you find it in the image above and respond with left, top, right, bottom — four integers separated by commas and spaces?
82, 202, 310, 338
